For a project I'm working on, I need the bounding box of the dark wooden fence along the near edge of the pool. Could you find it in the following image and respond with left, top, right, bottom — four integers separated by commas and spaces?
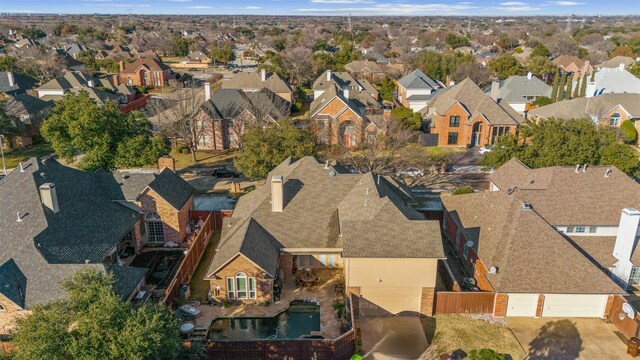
207, 329, 356, 360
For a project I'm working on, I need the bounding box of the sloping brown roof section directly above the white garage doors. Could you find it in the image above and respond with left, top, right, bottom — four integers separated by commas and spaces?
442, 191, 624, 294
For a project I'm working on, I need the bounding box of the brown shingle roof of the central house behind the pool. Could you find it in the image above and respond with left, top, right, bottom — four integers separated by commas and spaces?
207, 157, 444, 276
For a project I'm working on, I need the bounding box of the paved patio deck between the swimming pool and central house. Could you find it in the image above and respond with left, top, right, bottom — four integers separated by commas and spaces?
196, 269, 343, 339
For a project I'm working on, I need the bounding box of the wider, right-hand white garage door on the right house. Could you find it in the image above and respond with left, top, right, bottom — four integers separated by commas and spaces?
542, 295, 609, 317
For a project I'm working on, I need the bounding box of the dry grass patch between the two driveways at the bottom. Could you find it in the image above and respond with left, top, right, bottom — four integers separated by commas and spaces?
423, 315, 526, 359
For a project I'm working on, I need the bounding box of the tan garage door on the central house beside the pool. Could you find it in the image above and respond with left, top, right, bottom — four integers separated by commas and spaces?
360, 287, 422, 314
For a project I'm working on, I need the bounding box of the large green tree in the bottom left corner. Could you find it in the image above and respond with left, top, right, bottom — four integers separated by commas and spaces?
10, 268, 197, 360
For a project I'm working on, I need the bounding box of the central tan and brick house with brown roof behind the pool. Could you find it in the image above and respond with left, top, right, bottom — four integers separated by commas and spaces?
205, 157, 445, 315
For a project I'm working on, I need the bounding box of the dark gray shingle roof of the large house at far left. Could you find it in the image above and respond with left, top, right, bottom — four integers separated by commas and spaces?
0, 159, 193, 308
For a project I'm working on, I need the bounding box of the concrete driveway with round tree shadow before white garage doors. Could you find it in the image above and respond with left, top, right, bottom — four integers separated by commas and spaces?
507, 318, 629, 360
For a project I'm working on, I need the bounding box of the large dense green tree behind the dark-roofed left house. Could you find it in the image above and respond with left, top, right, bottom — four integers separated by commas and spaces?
40, 91, 168, 171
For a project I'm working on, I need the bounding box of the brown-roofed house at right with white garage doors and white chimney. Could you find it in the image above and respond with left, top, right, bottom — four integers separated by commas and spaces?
442, 159, 640, 318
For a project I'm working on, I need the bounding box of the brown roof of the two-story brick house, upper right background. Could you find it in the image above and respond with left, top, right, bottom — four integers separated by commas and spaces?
429, 78, 522, 125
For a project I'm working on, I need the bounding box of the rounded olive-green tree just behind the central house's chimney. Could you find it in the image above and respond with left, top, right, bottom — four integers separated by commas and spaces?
234, 120, 315, 179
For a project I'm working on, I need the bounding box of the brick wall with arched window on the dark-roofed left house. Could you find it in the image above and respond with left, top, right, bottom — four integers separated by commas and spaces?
138, 189, 193, 245
